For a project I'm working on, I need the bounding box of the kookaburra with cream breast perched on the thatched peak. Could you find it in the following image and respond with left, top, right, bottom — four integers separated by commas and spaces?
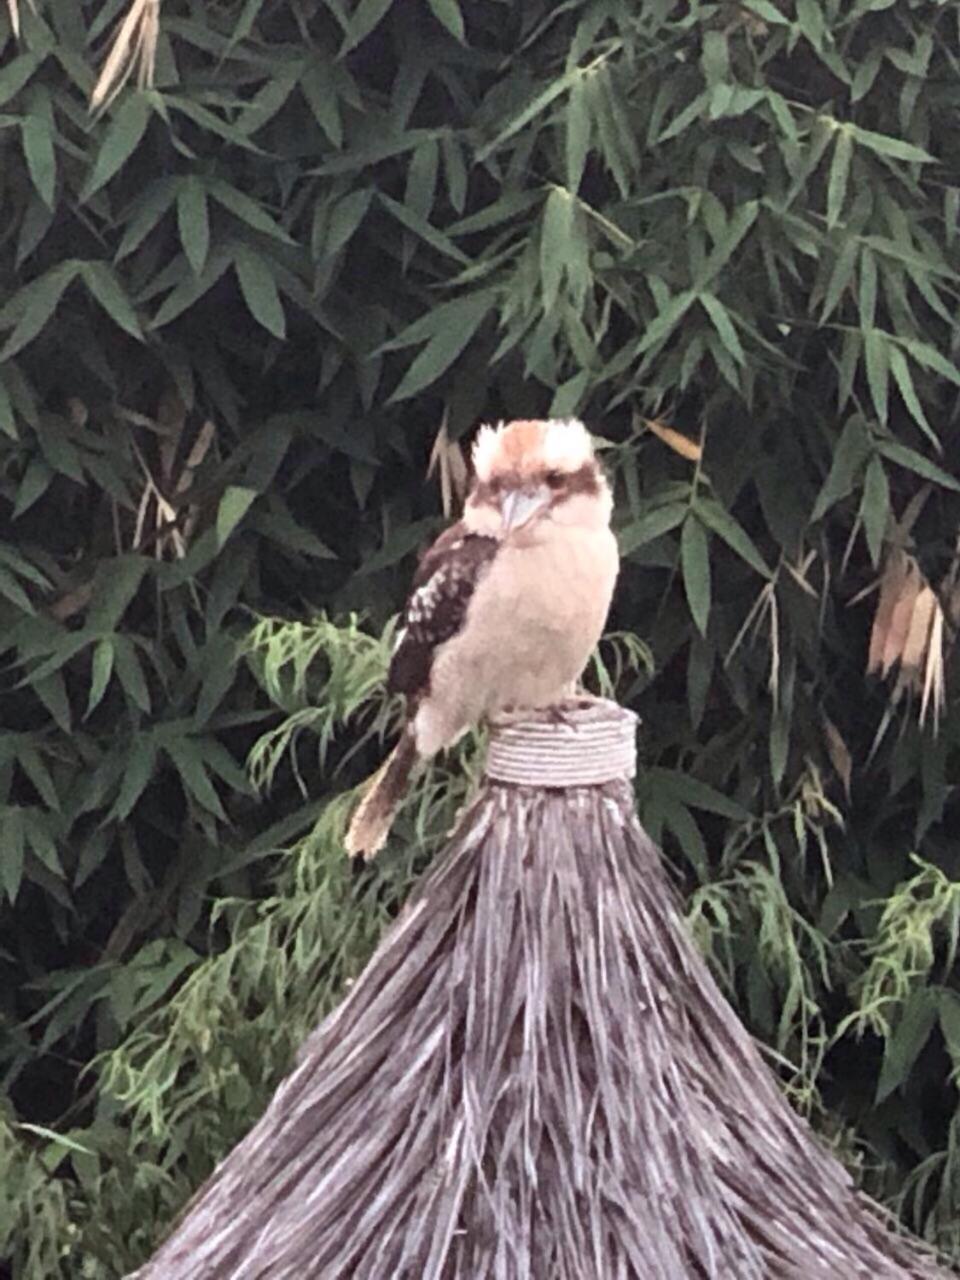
346, 420, 618, 858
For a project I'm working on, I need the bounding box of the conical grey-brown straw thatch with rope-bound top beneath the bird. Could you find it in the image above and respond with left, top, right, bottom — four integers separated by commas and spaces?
129, 704, 957, 1280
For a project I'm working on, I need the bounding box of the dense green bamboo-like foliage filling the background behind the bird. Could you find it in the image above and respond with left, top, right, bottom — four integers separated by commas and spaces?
0, 0, 960, 1280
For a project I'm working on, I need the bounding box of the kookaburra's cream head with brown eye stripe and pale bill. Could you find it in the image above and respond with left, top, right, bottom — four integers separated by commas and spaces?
466, 419, 612, 536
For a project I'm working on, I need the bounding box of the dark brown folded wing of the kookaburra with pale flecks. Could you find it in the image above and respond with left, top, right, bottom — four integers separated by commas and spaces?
387, 524, 499, 698
